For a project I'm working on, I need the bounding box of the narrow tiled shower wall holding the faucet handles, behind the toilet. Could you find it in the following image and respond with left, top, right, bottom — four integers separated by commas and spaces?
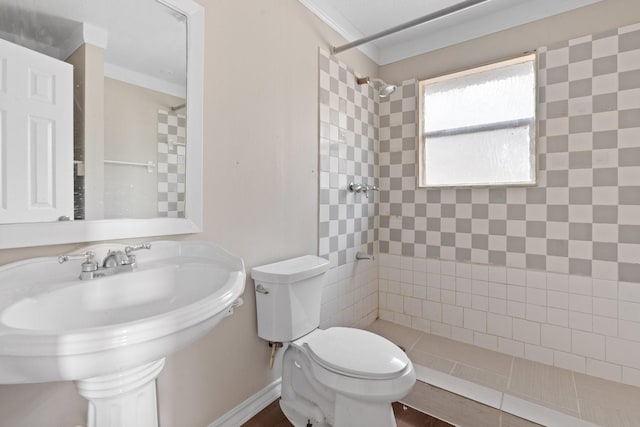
318, 50, 378, 327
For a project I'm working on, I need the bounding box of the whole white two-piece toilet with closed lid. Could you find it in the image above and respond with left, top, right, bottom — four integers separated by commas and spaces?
251, 255, 416, 427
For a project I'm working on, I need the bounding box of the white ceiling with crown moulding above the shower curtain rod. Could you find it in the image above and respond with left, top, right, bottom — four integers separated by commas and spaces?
299, 0, 601, 65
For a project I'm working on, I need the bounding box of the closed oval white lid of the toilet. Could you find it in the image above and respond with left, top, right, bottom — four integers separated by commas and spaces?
305, 327, 409, 379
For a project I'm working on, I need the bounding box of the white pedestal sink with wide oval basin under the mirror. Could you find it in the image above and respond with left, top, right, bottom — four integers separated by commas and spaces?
0, 241, 245, 427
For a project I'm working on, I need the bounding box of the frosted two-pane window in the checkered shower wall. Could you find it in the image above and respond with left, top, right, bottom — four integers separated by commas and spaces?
418, 54, 536, 187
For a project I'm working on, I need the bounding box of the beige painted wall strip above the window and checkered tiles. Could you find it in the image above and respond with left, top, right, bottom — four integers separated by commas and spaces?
379, 0, 640, 83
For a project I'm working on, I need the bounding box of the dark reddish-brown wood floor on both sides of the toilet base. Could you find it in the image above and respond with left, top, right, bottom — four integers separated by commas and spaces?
242, 400, 453, 427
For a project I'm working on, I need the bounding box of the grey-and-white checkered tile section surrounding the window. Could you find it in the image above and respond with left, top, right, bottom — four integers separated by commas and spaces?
379, 24, 640, 282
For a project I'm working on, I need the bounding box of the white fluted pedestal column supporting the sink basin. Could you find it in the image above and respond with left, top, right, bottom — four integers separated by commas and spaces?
76, 358, 164, 427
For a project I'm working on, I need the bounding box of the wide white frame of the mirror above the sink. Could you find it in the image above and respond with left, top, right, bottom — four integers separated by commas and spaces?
0, 0, 204, 249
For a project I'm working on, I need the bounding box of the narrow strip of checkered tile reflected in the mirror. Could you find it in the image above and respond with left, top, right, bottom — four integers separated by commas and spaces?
157, 110, 186, 218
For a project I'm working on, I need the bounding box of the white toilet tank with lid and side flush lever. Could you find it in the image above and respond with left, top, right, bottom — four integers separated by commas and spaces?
251, 255, 329, 342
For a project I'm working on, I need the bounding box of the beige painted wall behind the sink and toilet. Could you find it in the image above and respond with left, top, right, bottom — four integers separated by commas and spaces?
0, 0, 377, 427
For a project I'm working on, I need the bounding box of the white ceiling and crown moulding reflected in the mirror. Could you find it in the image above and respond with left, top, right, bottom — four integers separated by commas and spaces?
0, 0, 187, 97
